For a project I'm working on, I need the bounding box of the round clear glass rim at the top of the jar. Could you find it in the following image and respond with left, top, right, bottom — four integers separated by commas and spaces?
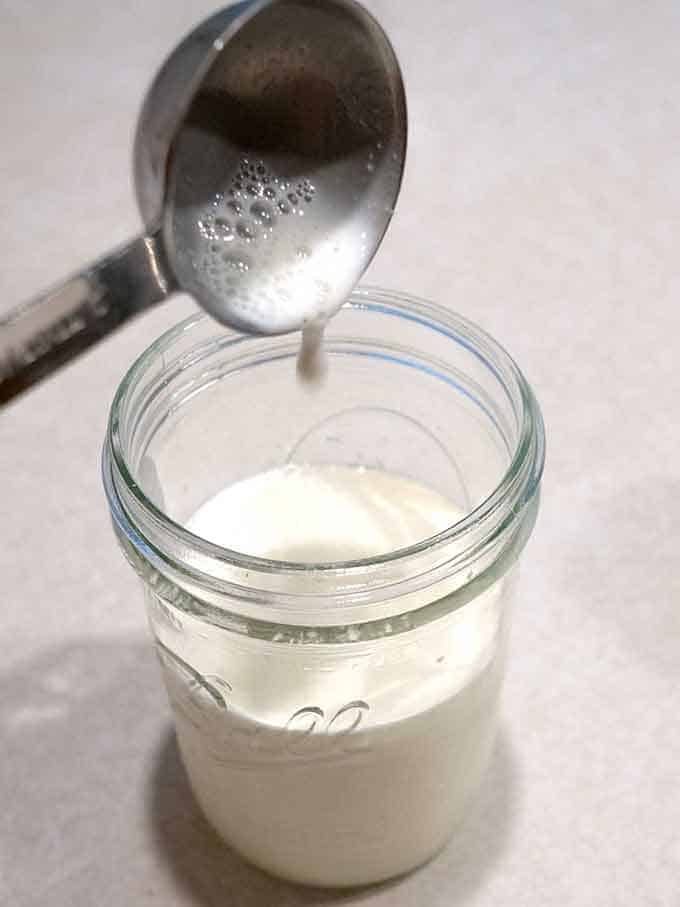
103, 286, 545, 628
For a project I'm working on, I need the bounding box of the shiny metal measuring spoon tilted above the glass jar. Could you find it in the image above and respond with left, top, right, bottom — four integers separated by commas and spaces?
0, 0, 406, 403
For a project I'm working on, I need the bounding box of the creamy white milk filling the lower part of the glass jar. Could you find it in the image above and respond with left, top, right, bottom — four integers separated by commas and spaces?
162, 467, 503, 886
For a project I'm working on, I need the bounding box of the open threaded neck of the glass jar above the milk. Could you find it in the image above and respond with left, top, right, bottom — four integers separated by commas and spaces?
104, 288, 544, 628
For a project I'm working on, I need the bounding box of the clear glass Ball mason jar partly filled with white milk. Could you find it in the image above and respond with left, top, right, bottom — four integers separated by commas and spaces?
103, 289, 544, 886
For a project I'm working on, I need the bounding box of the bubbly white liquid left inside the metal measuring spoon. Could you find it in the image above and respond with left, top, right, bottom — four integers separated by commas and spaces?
178, 149, 368, 334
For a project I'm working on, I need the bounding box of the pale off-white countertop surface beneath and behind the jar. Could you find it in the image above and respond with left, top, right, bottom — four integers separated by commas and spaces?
0, 0, 680, 907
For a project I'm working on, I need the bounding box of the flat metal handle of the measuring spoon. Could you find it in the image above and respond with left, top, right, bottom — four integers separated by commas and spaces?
0, 236, 175, 406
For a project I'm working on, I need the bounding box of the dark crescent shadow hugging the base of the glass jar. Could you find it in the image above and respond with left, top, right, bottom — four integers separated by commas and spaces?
149, 729, 518, 907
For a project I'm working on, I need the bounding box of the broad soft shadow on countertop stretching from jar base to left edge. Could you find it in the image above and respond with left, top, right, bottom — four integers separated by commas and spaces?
0, 634, 519, 907
